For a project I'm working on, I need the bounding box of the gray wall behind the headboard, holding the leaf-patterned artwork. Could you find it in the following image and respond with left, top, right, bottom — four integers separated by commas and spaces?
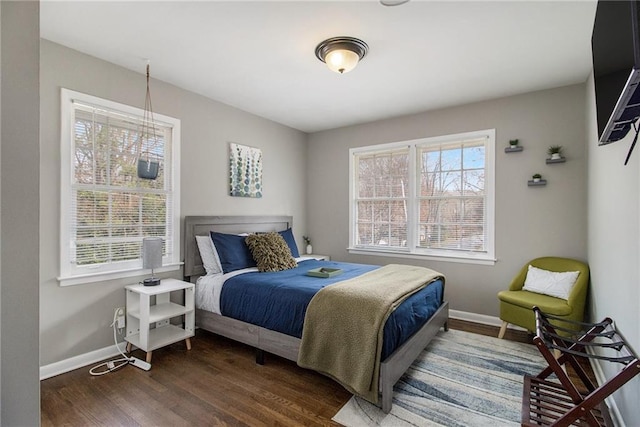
40, 40, 306, 365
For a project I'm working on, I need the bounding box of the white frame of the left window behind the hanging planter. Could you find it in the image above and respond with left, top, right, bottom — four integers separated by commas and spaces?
57, 88, 182, 286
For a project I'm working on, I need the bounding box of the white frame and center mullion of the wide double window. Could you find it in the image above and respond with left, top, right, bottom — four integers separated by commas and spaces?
347, 129, 496, 265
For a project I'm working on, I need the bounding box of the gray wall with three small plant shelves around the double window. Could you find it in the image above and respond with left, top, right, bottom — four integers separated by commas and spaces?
307, 85, 587, 316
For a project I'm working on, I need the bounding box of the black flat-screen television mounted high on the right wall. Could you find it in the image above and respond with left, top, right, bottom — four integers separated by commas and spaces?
591, 0, 640, 145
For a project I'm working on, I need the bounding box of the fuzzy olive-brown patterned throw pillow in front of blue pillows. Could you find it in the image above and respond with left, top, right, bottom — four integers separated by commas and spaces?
245, 233, 297, 272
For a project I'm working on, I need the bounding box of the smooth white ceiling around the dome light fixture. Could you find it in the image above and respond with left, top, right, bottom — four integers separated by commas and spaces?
40, 0, 596, 132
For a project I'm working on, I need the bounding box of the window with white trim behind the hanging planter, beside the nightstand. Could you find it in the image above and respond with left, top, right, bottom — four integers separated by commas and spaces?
59, 89, 180, 285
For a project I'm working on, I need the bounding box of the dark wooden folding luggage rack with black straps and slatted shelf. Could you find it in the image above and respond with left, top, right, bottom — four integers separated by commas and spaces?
522, 307, 640, 426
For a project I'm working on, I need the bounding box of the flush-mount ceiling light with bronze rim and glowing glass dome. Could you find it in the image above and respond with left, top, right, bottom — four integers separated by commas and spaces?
316, 37, 369, 74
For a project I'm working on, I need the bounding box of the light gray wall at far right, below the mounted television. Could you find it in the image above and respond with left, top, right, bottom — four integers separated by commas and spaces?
586, 75, 640, 426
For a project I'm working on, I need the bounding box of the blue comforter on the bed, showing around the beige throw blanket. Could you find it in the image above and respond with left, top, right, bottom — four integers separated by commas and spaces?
220, 260, 444, 360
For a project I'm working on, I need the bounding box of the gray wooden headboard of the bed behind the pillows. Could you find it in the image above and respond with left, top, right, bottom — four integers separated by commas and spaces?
184, 215, 293, 280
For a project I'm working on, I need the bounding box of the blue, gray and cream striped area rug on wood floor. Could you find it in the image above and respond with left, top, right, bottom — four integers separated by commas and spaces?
333, 330, 546, 427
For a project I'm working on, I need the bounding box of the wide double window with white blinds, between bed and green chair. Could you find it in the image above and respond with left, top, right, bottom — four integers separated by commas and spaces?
350, 129, 495, 263
